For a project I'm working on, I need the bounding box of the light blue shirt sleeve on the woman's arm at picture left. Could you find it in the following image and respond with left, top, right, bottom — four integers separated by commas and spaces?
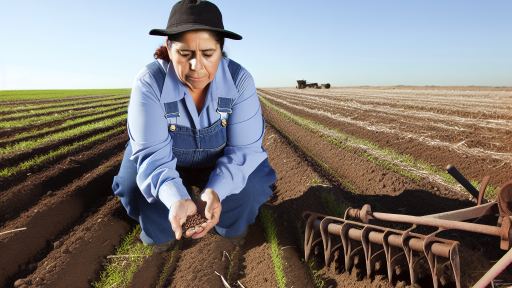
128, 68, 190, 208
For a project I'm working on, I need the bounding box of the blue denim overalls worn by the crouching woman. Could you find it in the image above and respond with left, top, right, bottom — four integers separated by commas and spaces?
112, 61, 277, 244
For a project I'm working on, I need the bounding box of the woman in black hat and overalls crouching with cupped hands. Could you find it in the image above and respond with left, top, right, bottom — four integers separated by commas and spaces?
112, 0, 277, 252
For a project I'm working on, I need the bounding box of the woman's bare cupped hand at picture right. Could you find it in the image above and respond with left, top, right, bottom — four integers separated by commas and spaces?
192, 188, 222, 239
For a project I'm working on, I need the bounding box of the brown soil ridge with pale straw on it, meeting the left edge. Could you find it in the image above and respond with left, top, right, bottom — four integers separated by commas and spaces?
0, 152, 123, 286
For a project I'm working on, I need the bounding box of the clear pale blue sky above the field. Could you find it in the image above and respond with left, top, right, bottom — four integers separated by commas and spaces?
0, 0, 512, 90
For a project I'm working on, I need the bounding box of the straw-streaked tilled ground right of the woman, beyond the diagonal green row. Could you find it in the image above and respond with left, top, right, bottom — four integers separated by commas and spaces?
260, 89, 512, 187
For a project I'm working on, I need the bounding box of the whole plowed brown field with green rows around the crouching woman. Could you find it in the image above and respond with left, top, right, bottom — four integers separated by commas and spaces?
0, 88, 512, 288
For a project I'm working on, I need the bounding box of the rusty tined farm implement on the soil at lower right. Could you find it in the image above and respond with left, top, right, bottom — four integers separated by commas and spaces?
303, 165, 512, 288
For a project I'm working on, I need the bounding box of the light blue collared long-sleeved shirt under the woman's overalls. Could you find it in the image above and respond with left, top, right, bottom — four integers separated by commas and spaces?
128, 58, 267, 208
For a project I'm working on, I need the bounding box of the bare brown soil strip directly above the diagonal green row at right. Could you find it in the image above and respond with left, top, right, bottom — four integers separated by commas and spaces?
260, 91, 512, 187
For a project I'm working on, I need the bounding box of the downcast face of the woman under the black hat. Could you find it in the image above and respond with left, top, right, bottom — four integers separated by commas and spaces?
167, 31, 222, 90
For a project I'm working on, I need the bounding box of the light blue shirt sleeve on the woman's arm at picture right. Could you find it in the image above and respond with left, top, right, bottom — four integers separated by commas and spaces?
206, 68, 267, 201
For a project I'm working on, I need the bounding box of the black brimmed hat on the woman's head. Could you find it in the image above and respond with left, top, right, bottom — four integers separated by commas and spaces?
149, 0, 242, 40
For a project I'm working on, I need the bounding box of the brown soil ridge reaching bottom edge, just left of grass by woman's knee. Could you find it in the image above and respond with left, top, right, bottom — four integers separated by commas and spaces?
13, 197, 130, 288
